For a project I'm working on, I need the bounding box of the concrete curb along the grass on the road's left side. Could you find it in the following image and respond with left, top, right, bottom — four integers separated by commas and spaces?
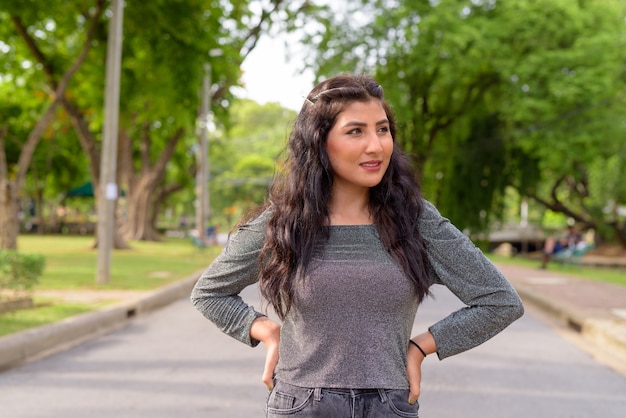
0, 273, 199, 371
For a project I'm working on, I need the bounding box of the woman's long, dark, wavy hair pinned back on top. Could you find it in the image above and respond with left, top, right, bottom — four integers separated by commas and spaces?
259, 75, 430, 319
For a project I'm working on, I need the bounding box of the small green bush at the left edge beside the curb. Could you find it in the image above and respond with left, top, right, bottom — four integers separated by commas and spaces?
0, 250, 45, 296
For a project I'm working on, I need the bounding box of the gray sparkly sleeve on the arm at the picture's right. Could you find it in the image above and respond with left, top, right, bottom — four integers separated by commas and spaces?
420, 201, 524, 360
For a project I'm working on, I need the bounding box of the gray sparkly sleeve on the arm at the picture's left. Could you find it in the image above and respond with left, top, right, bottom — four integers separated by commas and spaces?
191, 212, 267, 347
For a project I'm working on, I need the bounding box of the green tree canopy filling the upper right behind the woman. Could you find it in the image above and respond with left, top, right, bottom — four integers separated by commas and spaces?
296, 0, 626, 245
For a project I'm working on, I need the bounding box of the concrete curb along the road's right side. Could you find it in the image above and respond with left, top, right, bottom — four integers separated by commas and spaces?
515, 285, 626, 362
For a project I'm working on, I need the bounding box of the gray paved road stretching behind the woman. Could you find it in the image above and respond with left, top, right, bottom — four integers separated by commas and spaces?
0, 288, 626, 418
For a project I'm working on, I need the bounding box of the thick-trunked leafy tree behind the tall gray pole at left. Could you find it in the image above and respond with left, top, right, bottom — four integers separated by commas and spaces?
4, 0, 320, 247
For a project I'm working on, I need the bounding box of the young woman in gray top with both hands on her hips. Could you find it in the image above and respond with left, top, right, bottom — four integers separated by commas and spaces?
192, 75, 523, 418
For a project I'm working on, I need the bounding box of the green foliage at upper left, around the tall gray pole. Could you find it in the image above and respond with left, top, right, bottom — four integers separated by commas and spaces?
0, 0, 316, 243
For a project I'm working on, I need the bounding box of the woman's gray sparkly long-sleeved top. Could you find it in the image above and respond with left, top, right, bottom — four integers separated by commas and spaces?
191, 201, 524, 389
